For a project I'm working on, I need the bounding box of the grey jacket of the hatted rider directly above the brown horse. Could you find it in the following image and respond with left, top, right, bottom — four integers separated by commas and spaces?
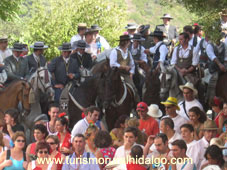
4, 55, 30, 82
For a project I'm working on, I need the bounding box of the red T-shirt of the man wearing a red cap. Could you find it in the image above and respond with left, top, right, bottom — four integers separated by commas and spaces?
139, 117, 159, 136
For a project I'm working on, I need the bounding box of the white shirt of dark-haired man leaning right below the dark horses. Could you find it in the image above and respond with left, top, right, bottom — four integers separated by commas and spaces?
71, 118, 89, 141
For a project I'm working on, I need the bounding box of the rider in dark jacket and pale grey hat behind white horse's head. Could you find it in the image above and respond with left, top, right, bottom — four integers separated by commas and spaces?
27, 42, 48, 72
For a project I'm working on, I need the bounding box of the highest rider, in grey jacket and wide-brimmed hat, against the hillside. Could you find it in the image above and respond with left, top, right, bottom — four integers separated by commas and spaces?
155, 14, 178, 46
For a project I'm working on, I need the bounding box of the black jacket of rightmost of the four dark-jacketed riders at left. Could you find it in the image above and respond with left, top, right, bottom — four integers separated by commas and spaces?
71, 52, 92, 70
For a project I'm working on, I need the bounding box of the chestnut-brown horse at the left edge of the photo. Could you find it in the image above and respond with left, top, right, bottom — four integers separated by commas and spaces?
0, 80, 30, 115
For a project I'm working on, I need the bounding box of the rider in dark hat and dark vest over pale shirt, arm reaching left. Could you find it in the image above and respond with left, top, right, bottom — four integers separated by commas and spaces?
145, 31, 168, 70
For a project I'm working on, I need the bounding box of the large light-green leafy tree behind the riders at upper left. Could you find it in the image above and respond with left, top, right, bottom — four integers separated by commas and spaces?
15, 0, 127, 59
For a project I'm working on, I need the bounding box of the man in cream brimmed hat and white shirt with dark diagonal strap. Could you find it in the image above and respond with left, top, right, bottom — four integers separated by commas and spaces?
177, 82, 203, 121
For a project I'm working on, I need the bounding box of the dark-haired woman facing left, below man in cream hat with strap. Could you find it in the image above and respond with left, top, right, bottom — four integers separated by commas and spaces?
189, 107, 207, 140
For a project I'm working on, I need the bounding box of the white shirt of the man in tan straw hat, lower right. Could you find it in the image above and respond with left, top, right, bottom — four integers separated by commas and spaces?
190, 137, 209, 169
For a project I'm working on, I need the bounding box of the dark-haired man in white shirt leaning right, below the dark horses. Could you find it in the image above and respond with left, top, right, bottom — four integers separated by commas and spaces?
71, 106, 100, 140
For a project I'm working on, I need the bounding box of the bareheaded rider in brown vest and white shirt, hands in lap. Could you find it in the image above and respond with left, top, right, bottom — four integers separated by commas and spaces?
171, 32, 199, 84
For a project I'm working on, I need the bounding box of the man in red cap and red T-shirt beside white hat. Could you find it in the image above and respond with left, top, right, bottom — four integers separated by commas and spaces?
136, 102, 161, 136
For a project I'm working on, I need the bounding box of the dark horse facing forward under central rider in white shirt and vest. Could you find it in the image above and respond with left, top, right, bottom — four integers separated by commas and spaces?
99, 68, 135, 130
